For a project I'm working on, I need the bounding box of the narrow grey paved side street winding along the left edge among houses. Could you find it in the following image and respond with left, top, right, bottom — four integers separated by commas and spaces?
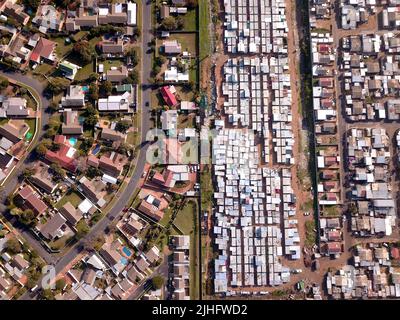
0, 70, 55, 263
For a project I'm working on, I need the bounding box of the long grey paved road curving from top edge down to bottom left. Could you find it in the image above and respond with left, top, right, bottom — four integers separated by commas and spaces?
20, 1, 153, 300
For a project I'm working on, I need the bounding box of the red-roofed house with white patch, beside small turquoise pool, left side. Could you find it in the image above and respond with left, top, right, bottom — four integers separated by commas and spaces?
45, 135, 78, 172
